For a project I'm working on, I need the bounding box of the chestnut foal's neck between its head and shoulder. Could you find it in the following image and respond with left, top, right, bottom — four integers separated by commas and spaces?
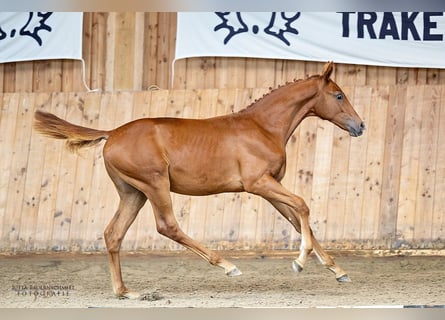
246, 78, 319, 145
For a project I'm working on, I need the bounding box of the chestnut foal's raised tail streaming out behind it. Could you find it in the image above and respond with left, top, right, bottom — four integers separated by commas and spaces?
34, 110, 111, 152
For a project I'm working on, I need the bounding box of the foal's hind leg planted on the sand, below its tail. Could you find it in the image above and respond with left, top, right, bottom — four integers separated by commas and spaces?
104, 177, 147, 299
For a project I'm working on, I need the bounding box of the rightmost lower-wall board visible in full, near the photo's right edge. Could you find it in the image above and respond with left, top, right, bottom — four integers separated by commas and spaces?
414, 86, 444, 248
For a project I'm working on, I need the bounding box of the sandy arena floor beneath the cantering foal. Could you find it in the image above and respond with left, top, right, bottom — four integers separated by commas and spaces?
0, 252, 445, 308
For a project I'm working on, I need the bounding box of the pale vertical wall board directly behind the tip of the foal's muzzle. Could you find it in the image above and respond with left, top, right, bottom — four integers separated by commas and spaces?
342, 86, 374, 241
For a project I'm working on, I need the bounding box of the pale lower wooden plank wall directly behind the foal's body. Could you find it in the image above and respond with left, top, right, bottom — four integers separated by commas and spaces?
0, 85, 445, 251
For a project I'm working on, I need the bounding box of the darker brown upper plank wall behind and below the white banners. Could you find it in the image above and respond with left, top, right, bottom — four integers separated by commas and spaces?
0, 12, 445, 92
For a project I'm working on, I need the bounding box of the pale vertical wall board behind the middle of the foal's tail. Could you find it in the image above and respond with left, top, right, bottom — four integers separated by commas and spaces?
52, 93, 83, 251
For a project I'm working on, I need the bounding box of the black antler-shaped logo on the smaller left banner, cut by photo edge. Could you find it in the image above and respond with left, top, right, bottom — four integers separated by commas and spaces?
0, 12, 53, 46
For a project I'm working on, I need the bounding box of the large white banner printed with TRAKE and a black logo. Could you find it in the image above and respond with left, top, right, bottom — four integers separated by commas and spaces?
175, 12, 445, 68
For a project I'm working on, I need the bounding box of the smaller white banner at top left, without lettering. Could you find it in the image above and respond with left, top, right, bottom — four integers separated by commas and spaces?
0, 12, 83, 63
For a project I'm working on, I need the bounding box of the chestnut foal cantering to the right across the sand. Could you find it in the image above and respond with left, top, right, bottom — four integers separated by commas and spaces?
35, 62, 365, 298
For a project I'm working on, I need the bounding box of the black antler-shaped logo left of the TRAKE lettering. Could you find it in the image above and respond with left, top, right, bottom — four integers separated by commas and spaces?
214, 12, 300, 46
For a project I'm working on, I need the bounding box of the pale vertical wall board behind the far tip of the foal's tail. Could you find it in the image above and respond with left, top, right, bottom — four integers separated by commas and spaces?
35, 93, 68, 250
